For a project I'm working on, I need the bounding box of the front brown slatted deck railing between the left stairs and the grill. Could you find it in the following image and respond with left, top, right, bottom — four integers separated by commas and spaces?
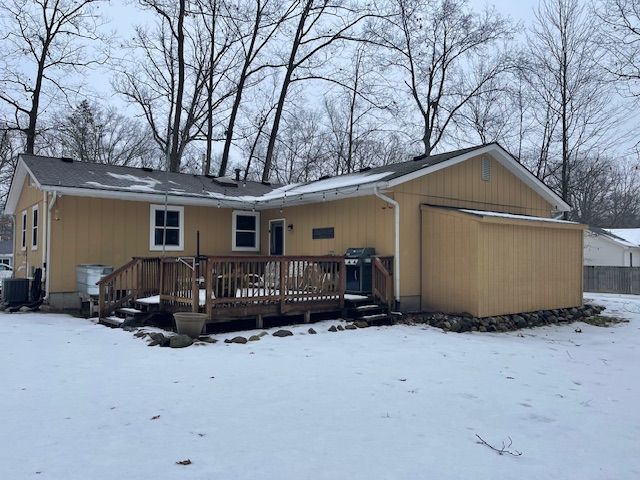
160, 256, 345, 318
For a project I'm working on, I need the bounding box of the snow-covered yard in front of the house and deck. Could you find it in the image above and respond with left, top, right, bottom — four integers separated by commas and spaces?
0, 294, 640, 480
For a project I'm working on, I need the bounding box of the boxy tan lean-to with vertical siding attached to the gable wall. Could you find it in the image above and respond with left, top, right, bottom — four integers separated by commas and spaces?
421, 207, 583, 317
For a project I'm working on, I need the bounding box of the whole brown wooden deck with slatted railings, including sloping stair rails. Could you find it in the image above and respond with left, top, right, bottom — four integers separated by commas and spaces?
98, 256, 393, 325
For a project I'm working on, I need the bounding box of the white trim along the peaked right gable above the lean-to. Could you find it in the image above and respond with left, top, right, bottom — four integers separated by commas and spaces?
387, 144, 571, 212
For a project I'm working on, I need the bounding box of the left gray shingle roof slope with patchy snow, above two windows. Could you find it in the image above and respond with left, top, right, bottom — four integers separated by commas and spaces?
21, 154, 277, 198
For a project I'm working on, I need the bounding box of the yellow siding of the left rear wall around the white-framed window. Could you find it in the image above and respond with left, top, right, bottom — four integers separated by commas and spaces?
50, 195, 237, 293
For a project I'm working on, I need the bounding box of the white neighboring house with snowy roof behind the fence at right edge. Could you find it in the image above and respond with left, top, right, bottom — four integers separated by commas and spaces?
584, 227, 640, 267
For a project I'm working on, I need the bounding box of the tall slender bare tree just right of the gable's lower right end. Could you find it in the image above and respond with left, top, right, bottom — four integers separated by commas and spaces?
527, 0, 619, 201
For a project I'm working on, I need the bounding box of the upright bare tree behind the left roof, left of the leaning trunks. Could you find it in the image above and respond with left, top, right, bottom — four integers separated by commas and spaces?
114, 0, 230, 171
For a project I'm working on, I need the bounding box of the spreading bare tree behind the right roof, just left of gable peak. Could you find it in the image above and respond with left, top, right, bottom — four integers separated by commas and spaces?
371, 0, 512, 155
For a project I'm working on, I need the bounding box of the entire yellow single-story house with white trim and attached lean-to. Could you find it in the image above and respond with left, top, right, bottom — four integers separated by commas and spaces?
6, 143, 583, 316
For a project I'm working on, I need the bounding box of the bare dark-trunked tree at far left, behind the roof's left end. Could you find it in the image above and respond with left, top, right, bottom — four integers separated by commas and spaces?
0, 0, 106, 153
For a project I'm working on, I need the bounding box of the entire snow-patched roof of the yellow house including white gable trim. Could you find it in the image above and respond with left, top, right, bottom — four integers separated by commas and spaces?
7, 143, 569, 211
